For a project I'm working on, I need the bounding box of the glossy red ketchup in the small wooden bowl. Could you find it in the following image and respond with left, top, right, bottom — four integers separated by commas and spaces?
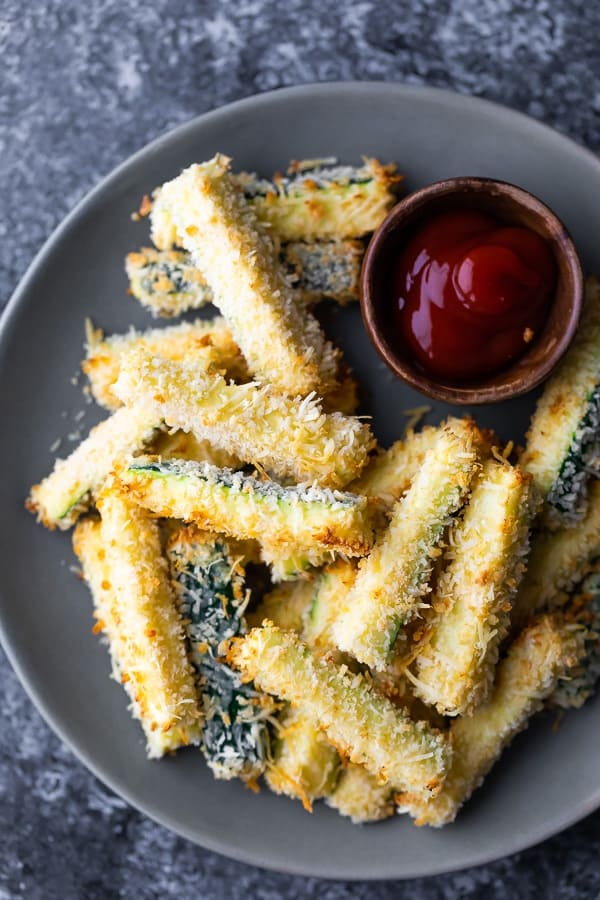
393, 209, 556, 382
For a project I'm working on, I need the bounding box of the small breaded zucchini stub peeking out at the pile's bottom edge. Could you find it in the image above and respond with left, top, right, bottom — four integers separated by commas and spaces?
325, 763, 395, 825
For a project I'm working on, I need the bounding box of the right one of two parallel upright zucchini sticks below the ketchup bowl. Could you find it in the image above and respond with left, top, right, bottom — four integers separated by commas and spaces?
411, 460, 531, 716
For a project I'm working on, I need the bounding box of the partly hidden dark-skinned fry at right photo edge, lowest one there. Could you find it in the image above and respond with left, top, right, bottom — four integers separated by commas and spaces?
548, 558, 600, 709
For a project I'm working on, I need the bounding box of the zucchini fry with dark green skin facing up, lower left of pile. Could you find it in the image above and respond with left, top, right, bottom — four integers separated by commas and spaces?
167, 526, 274, 781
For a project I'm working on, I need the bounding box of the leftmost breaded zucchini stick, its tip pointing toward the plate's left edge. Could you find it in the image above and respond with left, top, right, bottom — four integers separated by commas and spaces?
25, 407, 161, 530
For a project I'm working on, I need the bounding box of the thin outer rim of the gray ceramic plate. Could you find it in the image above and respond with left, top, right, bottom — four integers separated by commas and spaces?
0, 80, 600, 882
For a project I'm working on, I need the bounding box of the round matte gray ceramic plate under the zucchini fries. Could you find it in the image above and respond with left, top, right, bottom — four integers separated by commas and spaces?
0, 84, 600, 878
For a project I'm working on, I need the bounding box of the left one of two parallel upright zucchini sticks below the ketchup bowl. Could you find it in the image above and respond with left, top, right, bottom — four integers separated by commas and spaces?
333, 426, 477, 670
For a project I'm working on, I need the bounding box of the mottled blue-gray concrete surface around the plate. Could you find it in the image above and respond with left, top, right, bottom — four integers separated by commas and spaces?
0, 0, 600, 900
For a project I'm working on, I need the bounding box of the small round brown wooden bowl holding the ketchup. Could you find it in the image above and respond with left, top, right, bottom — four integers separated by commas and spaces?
360, 178, 583, 404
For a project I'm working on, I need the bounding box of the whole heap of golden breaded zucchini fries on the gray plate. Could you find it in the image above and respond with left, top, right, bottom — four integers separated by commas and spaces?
27, 155, 600, 826
